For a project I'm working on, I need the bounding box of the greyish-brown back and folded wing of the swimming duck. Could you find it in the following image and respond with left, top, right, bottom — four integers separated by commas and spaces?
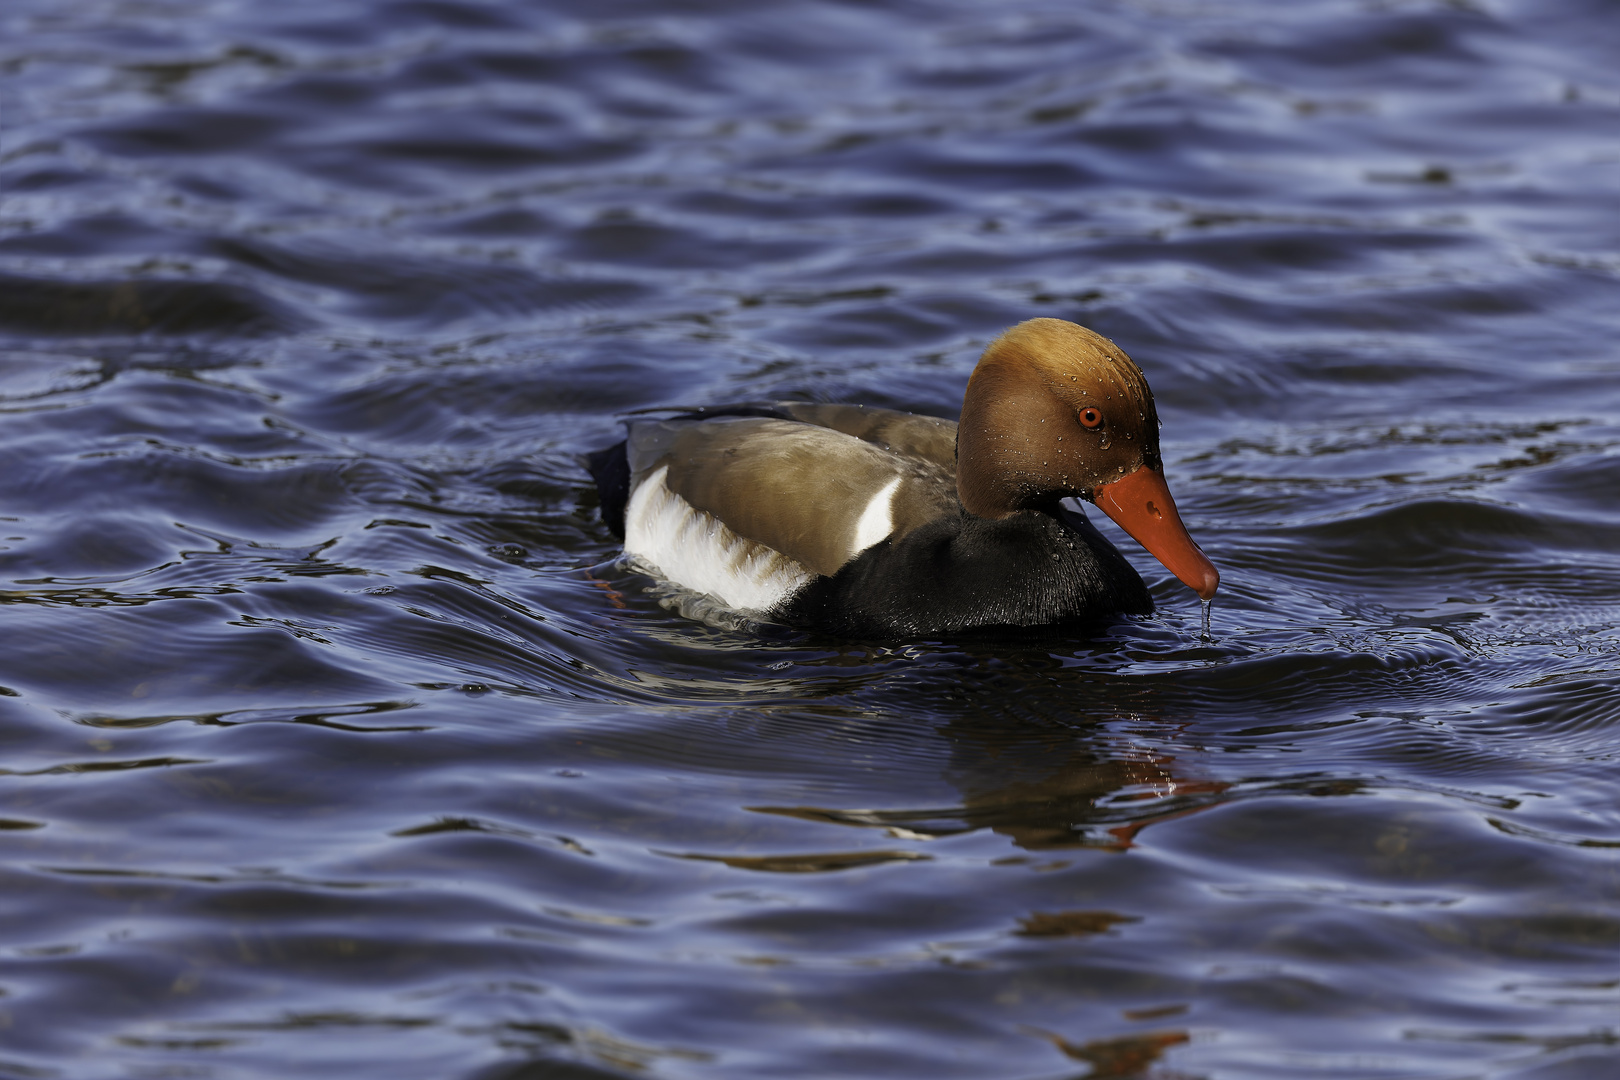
629, 417, 956, 575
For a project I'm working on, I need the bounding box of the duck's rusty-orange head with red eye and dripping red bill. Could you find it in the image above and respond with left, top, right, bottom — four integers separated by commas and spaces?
956, 319, 1220, 599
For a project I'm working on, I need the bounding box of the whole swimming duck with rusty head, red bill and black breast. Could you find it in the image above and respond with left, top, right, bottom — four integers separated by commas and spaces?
585, 319, 1220, 640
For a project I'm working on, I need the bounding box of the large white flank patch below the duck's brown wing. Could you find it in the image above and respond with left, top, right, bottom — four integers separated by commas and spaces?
624, 466, 816, 612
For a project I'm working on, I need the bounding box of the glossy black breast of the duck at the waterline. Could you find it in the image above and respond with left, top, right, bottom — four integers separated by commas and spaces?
776, 508, 1153, 638
